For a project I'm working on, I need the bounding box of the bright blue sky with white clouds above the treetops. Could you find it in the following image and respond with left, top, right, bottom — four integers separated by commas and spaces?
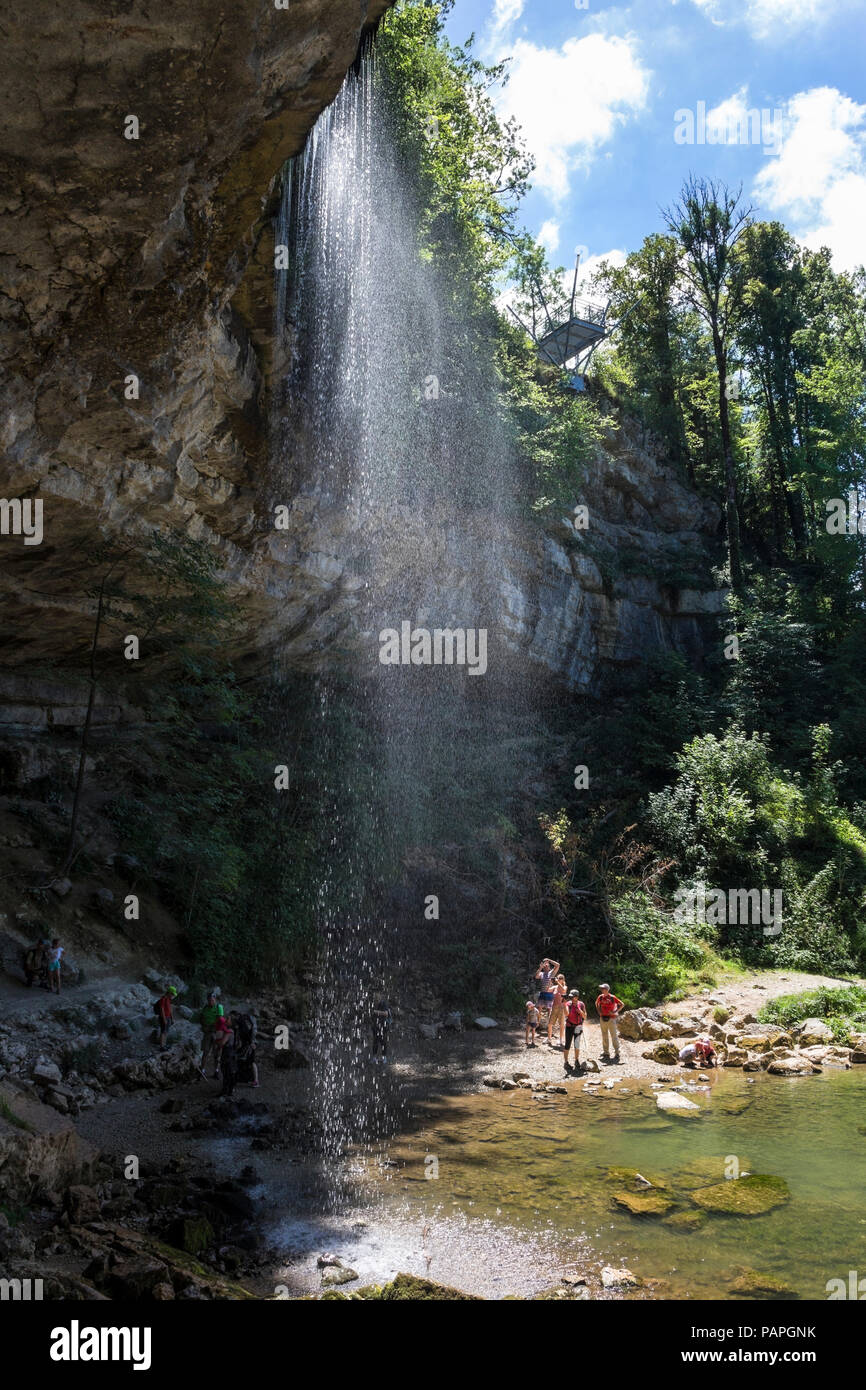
448, 0, 866, 284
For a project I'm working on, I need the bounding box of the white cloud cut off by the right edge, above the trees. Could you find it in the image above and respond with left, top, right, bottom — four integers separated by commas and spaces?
755, 88, 866, 270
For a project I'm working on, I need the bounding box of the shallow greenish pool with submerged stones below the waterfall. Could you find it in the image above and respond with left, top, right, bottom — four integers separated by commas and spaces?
335, 1069, 866, 1298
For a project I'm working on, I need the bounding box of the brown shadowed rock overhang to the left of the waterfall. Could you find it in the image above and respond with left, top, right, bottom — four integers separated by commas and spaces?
0, 0, 389, 663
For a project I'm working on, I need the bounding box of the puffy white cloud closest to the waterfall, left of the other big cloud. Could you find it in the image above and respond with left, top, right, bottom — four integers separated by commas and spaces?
498, 33, 649, 203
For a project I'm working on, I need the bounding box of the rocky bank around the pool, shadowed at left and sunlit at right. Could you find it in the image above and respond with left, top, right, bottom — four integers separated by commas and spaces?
0, 970, 866, 1300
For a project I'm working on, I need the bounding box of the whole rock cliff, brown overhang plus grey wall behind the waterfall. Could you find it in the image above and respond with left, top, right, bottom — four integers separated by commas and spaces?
0, 0, 720, 728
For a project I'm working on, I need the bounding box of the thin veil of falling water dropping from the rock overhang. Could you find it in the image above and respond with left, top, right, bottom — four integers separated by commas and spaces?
275, 38, 525, 1200
